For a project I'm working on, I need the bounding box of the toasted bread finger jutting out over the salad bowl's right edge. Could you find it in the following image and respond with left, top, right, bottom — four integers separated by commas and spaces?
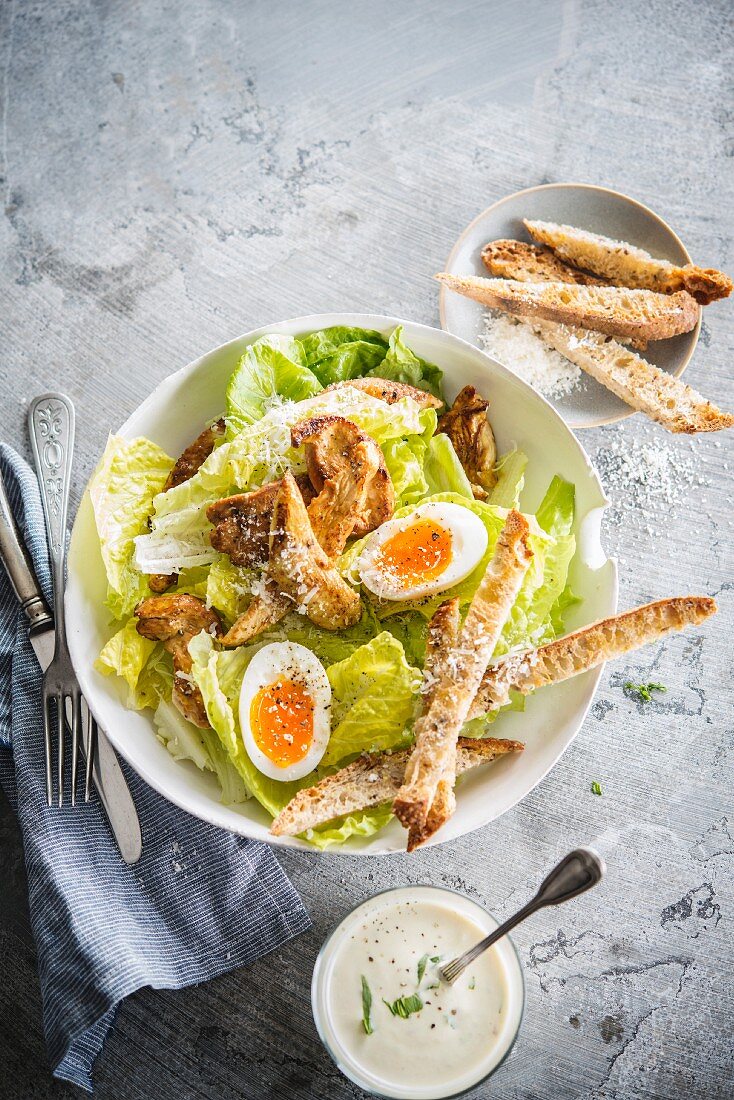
469, 596, 716, 718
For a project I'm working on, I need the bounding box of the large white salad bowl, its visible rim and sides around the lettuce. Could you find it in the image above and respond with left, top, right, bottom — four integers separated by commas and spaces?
66, 314, 617, 855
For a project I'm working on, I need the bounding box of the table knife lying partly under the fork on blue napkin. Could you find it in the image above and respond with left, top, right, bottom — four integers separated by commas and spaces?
0, 475, 143, 864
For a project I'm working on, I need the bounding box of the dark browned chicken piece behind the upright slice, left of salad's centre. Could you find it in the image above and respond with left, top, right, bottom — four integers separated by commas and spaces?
207, 474, 314, 569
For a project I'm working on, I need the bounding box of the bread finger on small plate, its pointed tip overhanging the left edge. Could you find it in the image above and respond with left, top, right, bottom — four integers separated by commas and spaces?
436, 274, 699, 340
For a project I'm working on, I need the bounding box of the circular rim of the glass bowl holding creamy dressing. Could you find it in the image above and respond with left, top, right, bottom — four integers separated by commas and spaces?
310, 882, 527, 1100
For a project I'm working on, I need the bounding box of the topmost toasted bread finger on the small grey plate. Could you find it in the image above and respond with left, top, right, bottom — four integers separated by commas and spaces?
525, 220, 734, 306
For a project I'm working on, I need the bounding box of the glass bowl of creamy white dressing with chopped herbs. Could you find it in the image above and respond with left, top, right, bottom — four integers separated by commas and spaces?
311, 886, 525, 1100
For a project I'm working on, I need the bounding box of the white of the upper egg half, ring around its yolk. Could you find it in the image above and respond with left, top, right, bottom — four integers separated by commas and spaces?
357, 501, 489, 600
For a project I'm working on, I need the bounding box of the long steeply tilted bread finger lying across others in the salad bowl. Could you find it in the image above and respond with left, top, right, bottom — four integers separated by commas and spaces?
394, 512, 533, 832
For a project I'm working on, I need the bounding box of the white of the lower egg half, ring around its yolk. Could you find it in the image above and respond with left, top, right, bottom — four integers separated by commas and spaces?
240, 641, 331, 783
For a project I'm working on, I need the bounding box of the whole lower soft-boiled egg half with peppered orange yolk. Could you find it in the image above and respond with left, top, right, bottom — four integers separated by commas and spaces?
240, 641, 331, 782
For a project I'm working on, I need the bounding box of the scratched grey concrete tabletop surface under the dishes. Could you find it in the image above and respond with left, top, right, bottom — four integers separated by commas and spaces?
0, 0, 734, 1100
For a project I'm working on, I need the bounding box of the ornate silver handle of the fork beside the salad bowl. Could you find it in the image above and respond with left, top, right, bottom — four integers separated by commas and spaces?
28, 394, 74, 644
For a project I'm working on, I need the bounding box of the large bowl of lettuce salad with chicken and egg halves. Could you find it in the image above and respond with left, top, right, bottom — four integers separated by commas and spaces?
67, 315, 633, 851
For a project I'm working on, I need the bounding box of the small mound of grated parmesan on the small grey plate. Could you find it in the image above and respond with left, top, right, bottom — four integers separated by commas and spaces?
479, 309, 581, 398
